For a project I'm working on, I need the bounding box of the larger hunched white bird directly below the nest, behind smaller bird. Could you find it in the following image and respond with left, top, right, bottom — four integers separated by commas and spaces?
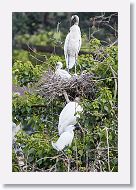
58, 97, 83, 135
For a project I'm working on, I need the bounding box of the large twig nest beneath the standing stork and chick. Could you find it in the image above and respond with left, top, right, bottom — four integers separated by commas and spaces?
34, 70, 96, 100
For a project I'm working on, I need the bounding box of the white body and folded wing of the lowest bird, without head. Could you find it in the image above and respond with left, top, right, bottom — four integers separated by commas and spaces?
52, 132, 74, 151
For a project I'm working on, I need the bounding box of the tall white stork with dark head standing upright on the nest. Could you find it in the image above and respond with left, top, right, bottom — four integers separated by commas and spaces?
64, 15, 82, 73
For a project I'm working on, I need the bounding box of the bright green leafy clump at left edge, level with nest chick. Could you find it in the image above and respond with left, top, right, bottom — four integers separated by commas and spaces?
12, 61, 43, 86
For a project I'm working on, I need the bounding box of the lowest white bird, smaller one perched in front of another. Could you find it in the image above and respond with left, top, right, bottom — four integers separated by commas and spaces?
52, 125, 75, 151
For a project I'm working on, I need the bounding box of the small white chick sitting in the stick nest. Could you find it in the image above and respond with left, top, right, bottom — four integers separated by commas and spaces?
55, 62, 71, 80
